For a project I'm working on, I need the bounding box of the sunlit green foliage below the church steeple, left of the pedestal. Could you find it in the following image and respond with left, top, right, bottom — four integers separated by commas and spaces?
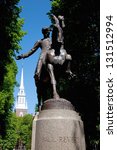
0, 113, 33, 150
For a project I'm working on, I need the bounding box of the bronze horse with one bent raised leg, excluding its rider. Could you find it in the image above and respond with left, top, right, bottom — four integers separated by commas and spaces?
47, 15, 74, 99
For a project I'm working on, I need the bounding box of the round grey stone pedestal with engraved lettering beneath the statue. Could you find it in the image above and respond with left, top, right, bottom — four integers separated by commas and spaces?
32, 99, 86, 150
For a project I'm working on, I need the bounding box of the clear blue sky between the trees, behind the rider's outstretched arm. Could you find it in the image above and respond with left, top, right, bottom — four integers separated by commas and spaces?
14, 0, 51, 114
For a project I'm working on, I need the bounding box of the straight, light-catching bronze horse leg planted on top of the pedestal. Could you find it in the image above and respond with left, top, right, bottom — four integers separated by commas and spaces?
48, 64, 59, 99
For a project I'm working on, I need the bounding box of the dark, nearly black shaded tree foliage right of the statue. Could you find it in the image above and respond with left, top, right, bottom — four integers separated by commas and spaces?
48, 0, 100, 150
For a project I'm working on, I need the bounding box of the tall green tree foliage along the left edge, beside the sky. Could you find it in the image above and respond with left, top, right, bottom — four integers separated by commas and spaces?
0, 0, 25, 136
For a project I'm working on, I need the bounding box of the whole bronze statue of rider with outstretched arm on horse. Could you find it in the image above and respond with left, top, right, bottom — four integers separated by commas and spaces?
16, 15, 74, 109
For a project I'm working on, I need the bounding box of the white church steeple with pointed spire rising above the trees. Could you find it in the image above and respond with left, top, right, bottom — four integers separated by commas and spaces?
16, 67, 28, 116
